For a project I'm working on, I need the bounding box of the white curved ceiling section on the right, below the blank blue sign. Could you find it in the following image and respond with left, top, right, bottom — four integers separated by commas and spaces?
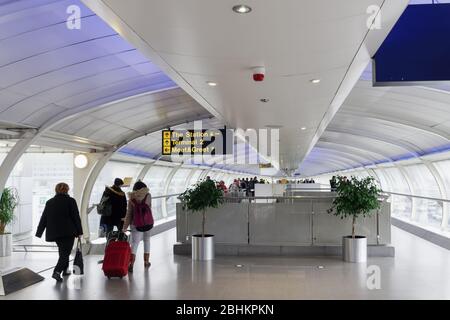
298, 80, 450, 176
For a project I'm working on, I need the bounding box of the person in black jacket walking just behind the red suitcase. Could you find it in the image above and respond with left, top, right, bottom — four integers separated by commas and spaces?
100, 178, 127, 233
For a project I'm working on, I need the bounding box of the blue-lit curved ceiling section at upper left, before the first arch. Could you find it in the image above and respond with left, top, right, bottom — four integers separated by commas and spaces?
0, 0, 175, 128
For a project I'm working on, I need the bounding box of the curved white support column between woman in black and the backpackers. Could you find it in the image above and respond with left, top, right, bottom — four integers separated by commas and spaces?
80, 151, 114, 241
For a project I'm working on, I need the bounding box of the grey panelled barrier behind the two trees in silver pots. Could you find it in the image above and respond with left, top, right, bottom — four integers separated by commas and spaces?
177, 193, 390, 246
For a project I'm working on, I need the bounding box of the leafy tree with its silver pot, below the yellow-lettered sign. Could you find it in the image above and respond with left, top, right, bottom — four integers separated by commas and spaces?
180, 179, 223, 260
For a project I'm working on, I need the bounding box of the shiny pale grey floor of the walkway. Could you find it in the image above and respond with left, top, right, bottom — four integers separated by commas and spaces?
0, 227, 450, 300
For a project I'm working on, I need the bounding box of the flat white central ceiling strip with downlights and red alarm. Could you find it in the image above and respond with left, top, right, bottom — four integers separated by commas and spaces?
84, 0, 408, 169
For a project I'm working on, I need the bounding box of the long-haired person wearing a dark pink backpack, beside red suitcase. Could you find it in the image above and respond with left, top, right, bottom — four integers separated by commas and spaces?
123, 181, 154, 272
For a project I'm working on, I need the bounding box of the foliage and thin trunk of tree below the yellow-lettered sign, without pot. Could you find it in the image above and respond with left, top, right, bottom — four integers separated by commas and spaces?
180, 180, 224, 237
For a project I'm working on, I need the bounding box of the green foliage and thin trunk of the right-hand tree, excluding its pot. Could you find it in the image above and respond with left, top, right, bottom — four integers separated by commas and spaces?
328, 176, 381, 239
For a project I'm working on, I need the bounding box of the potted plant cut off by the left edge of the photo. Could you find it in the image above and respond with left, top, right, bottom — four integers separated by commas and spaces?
0, 188, 19, 257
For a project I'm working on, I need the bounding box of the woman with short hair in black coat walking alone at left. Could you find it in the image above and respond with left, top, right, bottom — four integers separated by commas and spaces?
36, 183, 83, 282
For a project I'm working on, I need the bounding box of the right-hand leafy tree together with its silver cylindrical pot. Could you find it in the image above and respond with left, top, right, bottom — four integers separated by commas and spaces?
328, 176, 381, 262
